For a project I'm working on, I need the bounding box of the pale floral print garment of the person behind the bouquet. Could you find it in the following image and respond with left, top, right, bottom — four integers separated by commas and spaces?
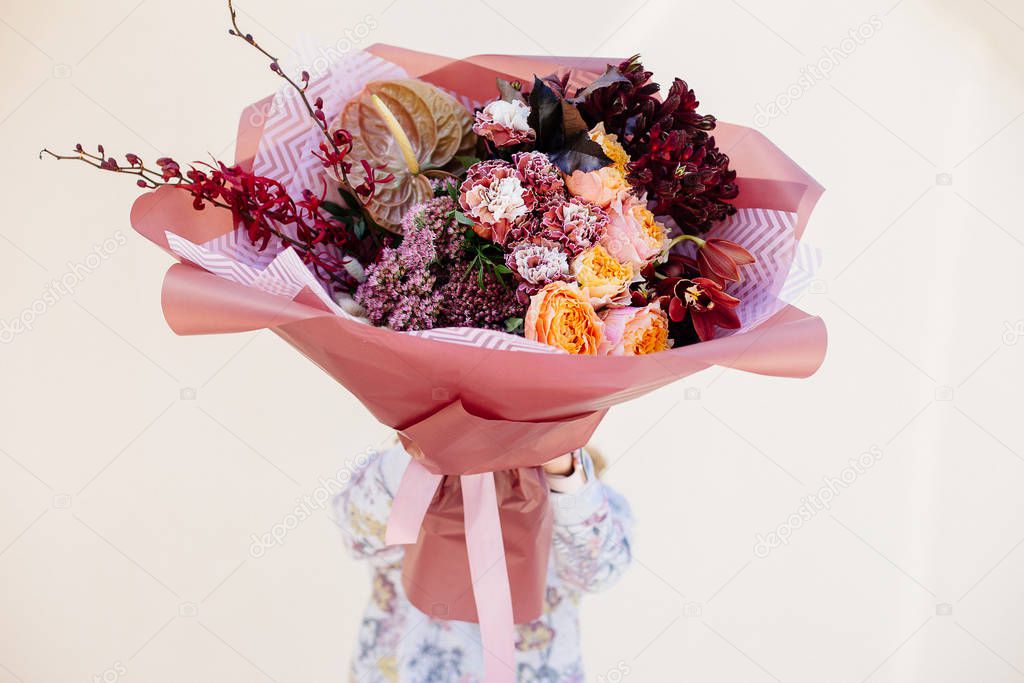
334, 446, 632, 683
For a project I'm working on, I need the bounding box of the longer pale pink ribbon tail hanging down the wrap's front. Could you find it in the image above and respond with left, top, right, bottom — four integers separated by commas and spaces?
460, 472, 515, 683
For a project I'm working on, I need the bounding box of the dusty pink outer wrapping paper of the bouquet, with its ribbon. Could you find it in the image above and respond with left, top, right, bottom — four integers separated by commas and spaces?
131, 45, 826, 683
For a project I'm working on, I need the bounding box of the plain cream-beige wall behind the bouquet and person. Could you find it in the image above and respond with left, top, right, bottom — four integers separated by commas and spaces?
0, 0, 1024, 683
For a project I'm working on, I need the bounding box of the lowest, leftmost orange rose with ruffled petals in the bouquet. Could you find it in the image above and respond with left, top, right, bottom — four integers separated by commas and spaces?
523, 282, 604, 355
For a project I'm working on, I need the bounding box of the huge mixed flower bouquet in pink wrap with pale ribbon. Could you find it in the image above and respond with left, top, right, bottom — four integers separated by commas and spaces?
41, 1, 825, 682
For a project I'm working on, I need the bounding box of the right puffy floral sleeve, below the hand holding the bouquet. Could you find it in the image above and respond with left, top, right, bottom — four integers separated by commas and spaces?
551, 453, 633, 593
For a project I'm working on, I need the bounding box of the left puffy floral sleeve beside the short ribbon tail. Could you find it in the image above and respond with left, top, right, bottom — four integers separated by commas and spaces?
334, 445, 410, 565
